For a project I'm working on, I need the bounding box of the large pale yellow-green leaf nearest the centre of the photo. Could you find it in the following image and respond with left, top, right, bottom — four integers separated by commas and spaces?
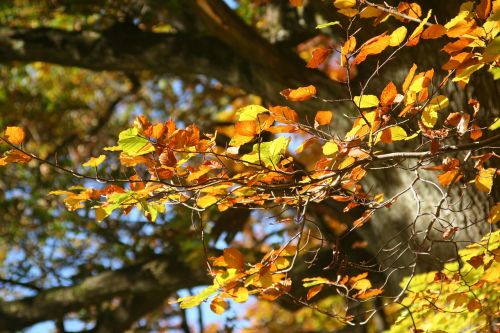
241, 136, 290, 168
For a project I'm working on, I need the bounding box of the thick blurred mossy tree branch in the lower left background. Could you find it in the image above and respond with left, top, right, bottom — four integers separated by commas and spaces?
0, 257, 206, 331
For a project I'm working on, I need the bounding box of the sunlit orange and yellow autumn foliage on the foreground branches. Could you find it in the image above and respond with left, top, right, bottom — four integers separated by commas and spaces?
0, 0, 500, 332
